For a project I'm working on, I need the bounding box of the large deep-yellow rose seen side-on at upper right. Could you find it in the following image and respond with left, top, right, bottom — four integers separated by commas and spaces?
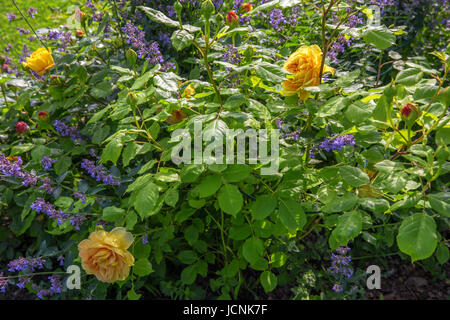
283, 45, 336, 100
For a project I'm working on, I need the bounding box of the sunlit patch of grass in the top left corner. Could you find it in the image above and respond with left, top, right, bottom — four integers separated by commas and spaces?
0, 0, 78, 63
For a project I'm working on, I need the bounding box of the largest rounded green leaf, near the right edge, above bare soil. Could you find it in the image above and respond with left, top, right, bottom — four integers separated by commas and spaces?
397, 213, 437, 262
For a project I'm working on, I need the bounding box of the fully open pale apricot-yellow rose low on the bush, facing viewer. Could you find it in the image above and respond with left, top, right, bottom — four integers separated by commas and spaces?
78, 228, 134, 283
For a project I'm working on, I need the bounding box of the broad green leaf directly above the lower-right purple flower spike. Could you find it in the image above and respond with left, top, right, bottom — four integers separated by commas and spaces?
332, 211, 362, 246
